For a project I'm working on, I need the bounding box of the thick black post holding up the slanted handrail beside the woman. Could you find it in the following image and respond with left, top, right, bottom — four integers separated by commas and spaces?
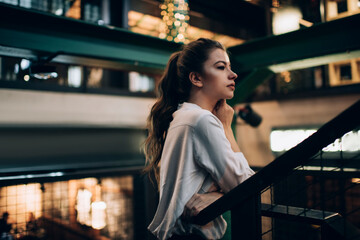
231, 193, 261, 240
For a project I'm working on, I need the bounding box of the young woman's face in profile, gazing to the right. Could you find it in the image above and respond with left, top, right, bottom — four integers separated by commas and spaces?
201, 48, 237, 101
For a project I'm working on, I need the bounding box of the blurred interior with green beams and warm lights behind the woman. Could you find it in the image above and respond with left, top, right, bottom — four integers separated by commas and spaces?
0, 0, 360, 240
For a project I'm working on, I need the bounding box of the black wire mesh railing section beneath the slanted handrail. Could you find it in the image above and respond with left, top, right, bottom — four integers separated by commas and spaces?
262, 138, 360, 239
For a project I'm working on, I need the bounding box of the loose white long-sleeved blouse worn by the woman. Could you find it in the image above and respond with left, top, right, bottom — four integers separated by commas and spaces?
148, 102, 254, 240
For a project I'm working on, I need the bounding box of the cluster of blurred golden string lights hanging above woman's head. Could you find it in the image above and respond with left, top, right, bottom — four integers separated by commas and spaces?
159, 0, 189, 42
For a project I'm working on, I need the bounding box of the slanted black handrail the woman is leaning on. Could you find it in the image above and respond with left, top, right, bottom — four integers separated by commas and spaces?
192, 100, 360, 225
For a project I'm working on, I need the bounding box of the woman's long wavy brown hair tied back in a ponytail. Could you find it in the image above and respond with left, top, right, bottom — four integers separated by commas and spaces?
144, 38, 225, 183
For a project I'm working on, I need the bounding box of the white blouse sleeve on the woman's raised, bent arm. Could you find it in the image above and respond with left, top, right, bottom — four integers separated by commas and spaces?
193, 114, 254, 192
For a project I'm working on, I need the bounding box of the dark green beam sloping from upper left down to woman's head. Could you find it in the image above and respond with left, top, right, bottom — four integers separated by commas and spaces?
0, 4, 181, 72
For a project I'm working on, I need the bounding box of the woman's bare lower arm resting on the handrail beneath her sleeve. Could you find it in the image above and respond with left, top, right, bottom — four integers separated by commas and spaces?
183, 192, 224, 219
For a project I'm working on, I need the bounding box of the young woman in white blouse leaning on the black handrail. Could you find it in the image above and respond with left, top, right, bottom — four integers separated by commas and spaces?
145, 38, 253, 240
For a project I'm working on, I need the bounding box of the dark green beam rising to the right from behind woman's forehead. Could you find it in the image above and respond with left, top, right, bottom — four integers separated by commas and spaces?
228, 14, 360, 72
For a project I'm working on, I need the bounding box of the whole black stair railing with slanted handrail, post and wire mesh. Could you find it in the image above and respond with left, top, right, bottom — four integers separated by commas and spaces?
193, 100, 360, 240
